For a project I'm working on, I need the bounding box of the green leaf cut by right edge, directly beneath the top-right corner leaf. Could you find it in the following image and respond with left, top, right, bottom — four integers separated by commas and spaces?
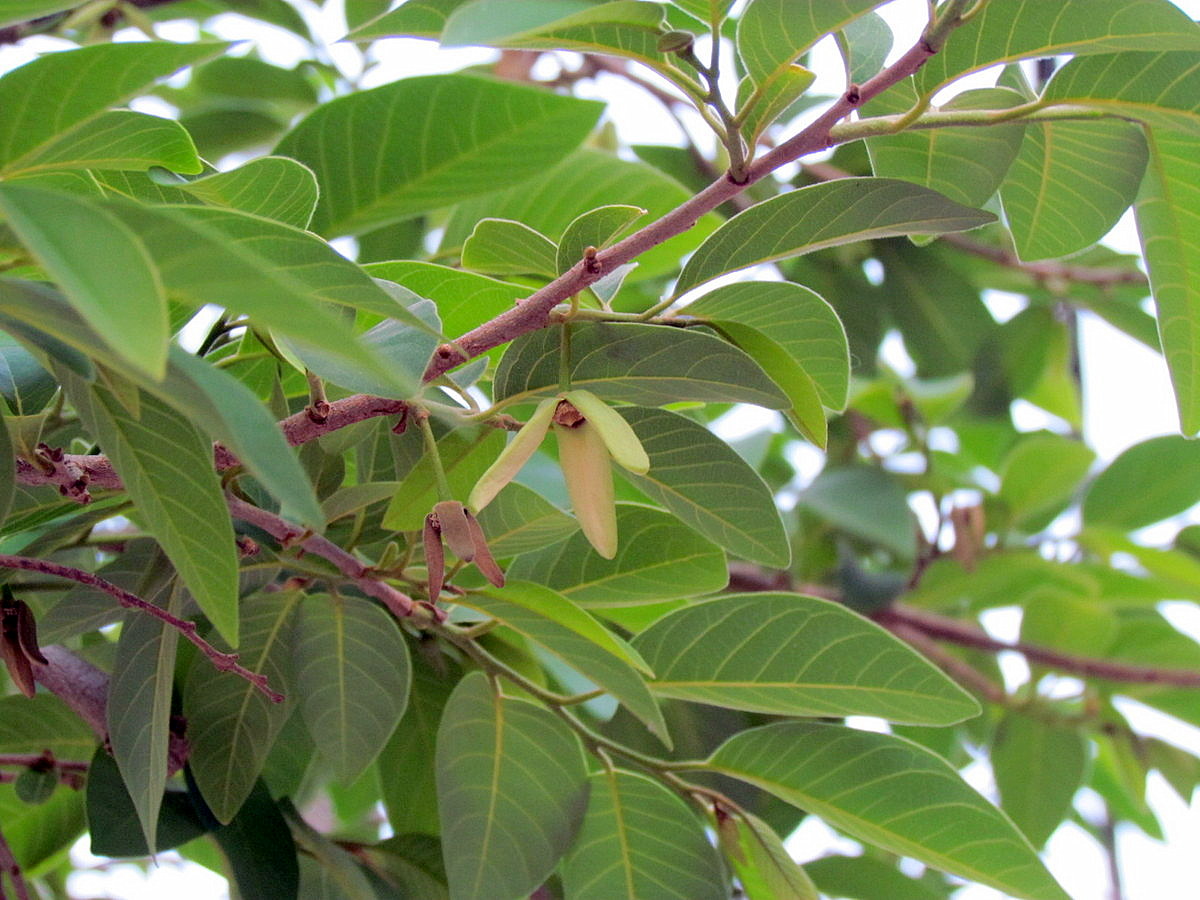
1043, 51, 1200, 139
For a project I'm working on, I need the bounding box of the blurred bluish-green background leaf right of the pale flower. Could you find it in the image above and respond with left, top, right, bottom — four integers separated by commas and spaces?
798, 466, 917, 559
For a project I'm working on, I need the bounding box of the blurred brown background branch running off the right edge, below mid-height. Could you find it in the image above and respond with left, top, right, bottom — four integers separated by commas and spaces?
874, 605, 1200, 688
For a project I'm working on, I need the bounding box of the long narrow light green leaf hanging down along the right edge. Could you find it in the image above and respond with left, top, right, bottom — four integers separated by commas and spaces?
1135, 128, 1200, 437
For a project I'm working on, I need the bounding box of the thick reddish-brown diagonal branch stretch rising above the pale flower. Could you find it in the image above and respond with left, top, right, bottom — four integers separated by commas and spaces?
425, 26, 937, 382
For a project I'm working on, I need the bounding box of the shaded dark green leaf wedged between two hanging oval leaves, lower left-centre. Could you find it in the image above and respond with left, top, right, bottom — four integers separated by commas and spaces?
379, 655, 457, 834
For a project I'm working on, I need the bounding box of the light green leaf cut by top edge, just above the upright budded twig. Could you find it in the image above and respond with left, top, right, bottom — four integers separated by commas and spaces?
737, 0, 883, 84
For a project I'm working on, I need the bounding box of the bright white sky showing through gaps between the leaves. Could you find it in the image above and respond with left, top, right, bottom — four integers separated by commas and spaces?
7, 0, 1200, 900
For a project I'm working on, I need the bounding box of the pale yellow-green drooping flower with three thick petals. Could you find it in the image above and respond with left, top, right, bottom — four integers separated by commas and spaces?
468, 390, 650, 559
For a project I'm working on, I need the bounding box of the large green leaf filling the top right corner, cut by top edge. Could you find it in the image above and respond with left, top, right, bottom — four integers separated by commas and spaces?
917, 0, 1200, 94
